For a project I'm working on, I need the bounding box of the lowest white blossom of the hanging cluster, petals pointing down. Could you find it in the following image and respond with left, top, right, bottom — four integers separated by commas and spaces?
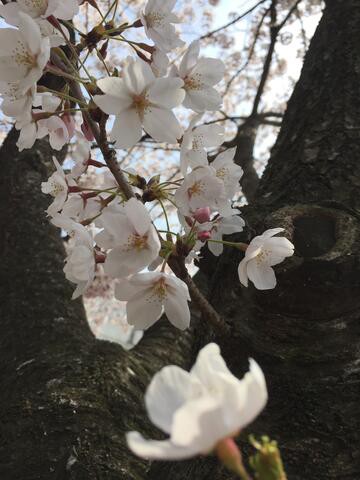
115, 272, 190, 330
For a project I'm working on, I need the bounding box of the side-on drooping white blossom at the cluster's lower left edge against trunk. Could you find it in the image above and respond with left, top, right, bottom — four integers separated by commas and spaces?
51, 214, 96, 299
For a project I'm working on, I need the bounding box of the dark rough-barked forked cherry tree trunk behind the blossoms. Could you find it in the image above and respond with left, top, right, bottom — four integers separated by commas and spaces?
0, 0, 360, 480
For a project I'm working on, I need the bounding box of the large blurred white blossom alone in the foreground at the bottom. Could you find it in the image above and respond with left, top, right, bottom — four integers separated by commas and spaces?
127, 343, 268, 460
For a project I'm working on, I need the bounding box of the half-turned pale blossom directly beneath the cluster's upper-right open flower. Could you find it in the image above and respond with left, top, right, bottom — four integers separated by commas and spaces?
180, 115, 224, 175
